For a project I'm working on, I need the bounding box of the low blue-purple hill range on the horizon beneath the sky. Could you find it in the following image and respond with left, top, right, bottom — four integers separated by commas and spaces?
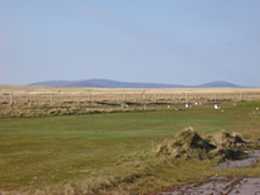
30, 79, 240, 88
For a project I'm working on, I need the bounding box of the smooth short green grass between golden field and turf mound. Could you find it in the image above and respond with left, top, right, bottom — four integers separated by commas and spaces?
0, 102, 260, 190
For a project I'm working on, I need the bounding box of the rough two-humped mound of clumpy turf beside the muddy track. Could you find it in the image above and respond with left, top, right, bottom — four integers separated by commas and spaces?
156, 127, 252, 160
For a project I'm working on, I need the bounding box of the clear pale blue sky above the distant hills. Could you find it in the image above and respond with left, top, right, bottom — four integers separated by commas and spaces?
0, 0, 260, 86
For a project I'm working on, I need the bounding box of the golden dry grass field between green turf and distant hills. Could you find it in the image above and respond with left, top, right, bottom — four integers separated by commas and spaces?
0, 86, 260, 117
